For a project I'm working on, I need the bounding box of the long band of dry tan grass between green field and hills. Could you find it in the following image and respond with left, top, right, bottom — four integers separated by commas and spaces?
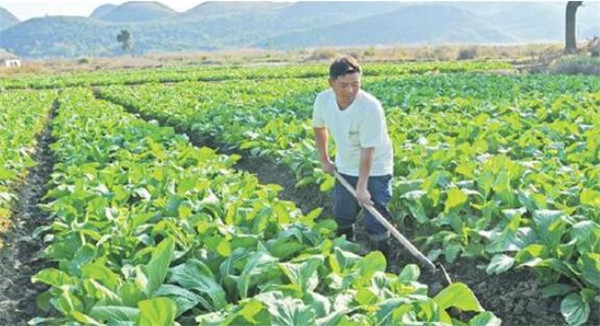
0, 44, 580, 78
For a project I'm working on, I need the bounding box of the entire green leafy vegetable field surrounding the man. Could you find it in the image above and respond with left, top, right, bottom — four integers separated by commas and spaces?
0, 62, 600, 326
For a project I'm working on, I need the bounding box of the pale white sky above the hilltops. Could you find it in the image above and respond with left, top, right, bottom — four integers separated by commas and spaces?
0, 0, 588, 21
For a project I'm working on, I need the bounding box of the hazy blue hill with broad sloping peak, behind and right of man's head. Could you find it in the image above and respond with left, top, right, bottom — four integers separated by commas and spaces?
257, 4, 515, 48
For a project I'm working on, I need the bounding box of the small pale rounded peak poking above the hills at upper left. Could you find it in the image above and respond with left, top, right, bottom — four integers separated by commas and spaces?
94, 1, 176, 23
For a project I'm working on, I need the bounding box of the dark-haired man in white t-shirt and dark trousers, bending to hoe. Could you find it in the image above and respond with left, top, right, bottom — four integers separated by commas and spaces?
313, 56, 393, 256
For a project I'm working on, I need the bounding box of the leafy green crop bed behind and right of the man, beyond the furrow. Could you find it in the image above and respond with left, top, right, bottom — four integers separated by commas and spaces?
102, 74, 600, 324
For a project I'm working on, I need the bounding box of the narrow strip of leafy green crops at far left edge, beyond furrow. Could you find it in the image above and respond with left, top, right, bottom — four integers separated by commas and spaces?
0, 91, 55, 232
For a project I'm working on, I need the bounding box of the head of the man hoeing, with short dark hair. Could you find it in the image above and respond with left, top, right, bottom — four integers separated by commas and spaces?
329, 56, 361, 105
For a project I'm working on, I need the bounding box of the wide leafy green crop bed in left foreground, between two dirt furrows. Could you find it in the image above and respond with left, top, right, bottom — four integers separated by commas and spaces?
32, 89, 499, 325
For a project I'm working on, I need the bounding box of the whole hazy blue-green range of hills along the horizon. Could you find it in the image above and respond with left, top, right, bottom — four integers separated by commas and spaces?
0, 1, 600, 58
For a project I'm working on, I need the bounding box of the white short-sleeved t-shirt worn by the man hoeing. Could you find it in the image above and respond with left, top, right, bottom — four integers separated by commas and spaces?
313, 88, 394, 176
